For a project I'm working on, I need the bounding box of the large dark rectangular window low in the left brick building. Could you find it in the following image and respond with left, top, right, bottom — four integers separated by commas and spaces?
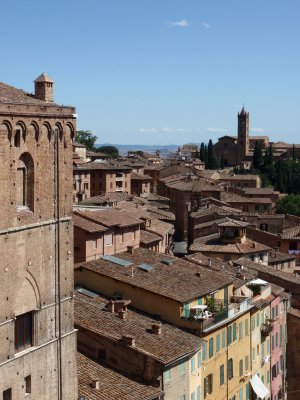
15, 312, 33, 352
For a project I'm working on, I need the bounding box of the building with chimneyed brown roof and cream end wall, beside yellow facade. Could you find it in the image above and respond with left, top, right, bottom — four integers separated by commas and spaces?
75, 287, 202, 400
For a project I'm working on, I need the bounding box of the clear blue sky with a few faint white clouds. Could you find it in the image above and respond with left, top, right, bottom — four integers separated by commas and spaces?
0, 0, 300, 145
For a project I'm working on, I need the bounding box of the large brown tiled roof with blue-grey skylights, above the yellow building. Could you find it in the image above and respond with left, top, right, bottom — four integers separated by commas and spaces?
75, 248, 232, 303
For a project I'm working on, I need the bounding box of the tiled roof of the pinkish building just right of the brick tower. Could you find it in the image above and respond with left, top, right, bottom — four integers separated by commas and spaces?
74, 208, 143, 227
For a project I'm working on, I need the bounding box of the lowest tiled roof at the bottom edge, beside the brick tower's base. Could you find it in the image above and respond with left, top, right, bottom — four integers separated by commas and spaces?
77, 352, 162, 400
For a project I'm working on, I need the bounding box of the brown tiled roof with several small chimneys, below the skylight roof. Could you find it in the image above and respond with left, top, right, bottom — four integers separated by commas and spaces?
74, 292, 201, 364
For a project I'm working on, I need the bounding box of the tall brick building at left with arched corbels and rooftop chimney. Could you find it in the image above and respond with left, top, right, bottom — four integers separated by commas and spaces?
0, 75, 77, 400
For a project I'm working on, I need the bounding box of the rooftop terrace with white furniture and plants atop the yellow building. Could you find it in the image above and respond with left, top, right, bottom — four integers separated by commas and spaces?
180, 296, 252, 331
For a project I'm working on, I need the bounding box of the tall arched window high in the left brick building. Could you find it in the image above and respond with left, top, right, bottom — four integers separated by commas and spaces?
16, 153, 34, 211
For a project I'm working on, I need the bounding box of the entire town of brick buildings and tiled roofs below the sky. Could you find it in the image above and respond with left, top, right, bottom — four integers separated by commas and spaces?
0, 73, 300, 400
